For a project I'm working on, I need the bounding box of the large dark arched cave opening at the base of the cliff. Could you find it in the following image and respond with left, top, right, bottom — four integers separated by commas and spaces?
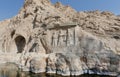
15, 36, 26, 53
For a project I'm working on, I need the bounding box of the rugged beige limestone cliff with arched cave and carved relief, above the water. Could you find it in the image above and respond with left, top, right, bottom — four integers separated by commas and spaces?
0, 0, 120, 75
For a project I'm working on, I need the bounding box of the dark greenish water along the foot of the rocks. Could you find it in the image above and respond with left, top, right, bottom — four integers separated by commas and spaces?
0, 71, 115, 77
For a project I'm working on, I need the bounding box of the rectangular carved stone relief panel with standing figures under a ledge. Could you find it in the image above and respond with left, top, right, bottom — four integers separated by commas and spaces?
47, 26, 78, 47
